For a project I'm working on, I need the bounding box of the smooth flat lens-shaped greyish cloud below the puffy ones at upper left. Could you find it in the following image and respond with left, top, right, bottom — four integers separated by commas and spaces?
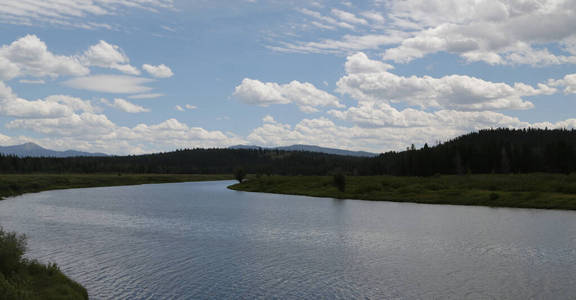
64, 75, 154, 94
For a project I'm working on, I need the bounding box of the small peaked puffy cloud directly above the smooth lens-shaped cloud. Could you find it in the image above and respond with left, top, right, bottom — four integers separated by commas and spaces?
82, 41, 140, 75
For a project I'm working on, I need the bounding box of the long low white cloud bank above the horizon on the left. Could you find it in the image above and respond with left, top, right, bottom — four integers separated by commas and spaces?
5, 113, 246, 154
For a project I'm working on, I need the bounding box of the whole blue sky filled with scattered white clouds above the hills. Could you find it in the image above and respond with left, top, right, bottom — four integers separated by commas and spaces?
0, 0, 576, 155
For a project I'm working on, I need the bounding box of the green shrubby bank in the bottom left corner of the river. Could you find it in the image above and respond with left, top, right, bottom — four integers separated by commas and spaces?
0, 228, 88, 300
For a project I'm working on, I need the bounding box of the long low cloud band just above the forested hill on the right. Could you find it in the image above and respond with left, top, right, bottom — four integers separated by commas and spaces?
247, 110, 576, 152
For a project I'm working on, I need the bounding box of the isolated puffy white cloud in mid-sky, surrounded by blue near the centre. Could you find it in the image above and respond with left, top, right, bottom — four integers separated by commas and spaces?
233, 78, 342, 113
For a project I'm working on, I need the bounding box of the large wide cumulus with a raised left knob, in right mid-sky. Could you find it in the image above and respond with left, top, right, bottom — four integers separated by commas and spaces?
337, 54, 556, 110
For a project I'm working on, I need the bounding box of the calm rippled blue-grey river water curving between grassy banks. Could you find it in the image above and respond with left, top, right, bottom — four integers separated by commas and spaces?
0, 181, 576, 299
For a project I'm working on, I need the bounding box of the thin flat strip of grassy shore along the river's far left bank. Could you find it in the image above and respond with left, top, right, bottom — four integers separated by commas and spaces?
0, 174, 233, 198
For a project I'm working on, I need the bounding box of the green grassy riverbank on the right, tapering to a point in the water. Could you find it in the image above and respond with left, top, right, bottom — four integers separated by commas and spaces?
230, 174, 576, 210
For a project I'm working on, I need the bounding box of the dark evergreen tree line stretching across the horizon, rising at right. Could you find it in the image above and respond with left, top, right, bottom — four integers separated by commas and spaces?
0, 128, 576, 176
